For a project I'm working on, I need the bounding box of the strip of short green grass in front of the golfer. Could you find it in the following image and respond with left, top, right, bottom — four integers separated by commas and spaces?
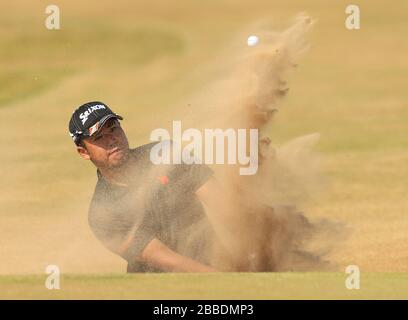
0, 273, 408, 300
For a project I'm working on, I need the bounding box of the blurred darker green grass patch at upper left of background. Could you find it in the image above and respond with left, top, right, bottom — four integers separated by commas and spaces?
0, 19, 184, 107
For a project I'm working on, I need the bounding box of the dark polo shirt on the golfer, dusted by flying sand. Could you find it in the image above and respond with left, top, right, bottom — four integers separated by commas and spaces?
89, 142, 213, 272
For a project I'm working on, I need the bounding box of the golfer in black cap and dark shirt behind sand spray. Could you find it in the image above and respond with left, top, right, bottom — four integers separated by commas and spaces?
69, 101, 216, 272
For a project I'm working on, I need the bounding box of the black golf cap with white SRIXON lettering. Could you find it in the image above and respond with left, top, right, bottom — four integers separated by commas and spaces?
69, 101, 123, 145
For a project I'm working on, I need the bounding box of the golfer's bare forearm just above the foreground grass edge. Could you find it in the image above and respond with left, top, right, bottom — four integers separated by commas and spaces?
139, 239, 217, 272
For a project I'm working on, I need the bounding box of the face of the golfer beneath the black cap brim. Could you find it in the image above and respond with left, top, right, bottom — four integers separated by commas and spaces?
77, 118, 129, 169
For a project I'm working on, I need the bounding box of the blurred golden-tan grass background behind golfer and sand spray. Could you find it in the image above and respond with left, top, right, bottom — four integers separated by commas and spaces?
0, 0, 408, 298
